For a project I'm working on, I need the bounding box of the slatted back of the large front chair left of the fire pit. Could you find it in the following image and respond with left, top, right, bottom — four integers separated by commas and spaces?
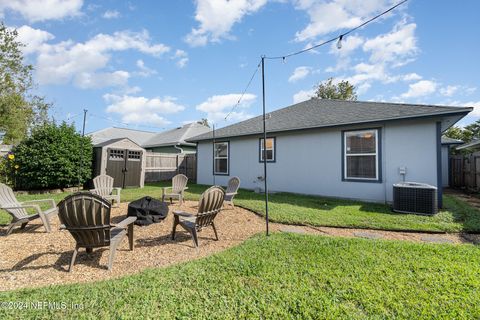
58, 192, 111, 248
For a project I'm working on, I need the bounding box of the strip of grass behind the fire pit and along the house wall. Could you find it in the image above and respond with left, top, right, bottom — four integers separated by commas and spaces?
0, 182, 480, 232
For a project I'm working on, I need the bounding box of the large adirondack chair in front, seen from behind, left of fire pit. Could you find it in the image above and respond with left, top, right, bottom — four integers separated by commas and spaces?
58, 192, 137, 272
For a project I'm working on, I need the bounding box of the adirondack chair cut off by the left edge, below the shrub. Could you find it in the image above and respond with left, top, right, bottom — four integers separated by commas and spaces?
0, 183, 58, 235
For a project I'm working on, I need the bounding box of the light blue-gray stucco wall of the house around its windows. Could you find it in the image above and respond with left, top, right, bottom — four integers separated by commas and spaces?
197, 119, 437, 202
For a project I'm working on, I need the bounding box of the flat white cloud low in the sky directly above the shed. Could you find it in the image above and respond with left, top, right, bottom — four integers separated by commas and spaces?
103, 94, 185, 126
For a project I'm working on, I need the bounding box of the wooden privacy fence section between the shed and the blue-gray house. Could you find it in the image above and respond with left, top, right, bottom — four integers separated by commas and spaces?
145, 152, 197, 182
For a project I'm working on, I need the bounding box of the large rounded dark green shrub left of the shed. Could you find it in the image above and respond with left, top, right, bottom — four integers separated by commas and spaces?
13, 123, 93, 190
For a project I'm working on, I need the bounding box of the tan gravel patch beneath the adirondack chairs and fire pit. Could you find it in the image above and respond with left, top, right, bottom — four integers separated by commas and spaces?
0, 201, 278, 291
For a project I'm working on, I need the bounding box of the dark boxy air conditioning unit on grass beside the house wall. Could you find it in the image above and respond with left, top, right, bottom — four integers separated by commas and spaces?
393, 182, 438, 215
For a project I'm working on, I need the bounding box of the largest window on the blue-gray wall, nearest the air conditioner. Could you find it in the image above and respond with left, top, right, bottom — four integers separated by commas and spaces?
344, 129, 379, 181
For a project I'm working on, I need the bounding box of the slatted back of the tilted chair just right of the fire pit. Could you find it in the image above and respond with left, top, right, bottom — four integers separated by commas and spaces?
195, 186, 225, 228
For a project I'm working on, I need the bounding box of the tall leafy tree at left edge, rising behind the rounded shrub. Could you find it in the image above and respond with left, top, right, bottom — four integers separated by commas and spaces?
0, 22, 51, 144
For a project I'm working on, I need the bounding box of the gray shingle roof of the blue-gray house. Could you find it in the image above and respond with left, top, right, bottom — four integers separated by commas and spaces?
189, 99, 472, 142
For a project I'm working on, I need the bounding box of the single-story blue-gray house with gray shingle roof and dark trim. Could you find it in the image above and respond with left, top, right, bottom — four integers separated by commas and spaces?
190, 99, 472, 207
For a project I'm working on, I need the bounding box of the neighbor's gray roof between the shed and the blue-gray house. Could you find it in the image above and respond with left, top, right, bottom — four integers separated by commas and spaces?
142, 122, 211, 148
